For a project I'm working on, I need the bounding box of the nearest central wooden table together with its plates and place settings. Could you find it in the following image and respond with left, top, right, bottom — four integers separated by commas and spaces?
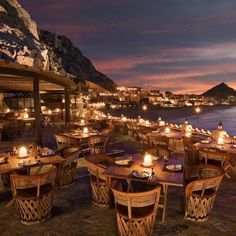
86, 154, 184, 222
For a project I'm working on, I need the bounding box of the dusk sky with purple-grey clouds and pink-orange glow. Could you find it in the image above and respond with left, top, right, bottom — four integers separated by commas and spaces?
19, 0, 236, 93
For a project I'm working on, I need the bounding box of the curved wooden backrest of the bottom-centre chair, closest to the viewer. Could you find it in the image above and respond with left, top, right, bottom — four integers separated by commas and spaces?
112, 187, 161, 219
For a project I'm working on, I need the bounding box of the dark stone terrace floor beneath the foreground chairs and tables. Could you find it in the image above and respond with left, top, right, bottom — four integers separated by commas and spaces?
0, 134, 236, 236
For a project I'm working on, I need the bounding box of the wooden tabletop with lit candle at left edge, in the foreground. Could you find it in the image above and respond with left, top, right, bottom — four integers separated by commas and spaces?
0, 155, 65, 174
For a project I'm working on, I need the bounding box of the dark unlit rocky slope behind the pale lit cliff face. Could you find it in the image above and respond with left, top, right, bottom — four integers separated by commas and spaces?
39, 30, 116, 90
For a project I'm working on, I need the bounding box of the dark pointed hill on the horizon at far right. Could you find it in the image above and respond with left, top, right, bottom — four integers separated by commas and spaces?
202, 83, 236, 99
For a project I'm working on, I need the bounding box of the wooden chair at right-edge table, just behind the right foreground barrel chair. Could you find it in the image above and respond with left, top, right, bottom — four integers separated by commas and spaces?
199, 149, 231, 178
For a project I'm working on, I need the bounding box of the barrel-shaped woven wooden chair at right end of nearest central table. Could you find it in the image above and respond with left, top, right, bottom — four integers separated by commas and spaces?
185, 164, 224, 221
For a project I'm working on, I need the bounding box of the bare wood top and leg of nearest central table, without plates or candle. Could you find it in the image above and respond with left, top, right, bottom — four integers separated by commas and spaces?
86, 155, 184, 222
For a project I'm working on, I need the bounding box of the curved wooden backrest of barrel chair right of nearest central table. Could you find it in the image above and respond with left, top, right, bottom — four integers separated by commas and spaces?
186, 164, 225, 198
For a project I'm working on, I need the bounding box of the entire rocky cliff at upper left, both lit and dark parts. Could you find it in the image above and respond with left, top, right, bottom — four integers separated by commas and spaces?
0, 0, 116, 90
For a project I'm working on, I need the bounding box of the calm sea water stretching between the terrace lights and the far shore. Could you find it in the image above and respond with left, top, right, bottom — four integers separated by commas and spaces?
105, 106, 236, 135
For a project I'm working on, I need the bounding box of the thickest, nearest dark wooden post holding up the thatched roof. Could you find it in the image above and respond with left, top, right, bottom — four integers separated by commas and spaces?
33, 78, 42, 145
